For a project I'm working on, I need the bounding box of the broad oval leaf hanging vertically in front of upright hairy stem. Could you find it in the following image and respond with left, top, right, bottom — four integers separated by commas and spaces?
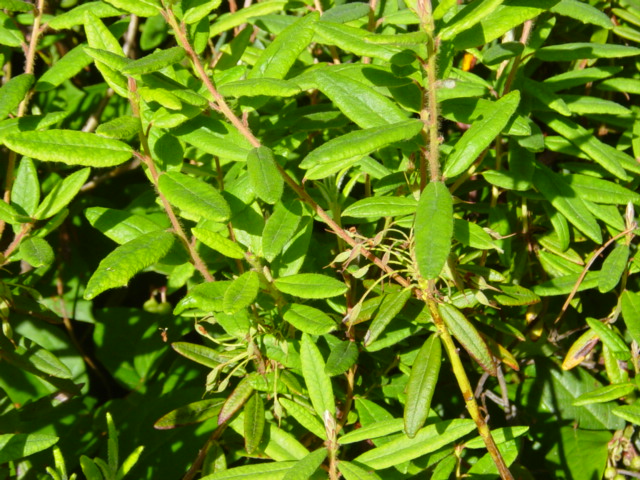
414, 182, 453, 279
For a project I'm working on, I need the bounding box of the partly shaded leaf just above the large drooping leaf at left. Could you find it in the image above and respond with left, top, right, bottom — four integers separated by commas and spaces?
84, 207, 162, 245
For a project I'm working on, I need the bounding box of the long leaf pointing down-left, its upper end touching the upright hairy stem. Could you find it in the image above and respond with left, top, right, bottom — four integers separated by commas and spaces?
300, 120, 423, 180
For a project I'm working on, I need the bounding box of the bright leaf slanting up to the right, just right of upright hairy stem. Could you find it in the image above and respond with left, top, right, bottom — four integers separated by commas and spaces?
443, 90, 520, 177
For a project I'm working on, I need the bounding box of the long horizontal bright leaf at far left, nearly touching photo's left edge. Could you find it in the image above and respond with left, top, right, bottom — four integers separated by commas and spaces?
5, 130, 132, 167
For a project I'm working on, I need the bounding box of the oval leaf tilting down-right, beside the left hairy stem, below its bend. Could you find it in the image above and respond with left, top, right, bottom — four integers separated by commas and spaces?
158, 172, 231, 222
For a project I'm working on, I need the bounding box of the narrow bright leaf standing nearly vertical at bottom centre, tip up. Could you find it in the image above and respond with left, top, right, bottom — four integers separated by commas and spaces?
300, 333, 336, 419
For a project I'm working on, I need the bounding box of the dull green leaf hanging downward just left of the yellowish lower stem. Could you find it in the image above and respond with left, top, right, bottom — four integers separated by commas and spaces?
404, 334, 442, 438
